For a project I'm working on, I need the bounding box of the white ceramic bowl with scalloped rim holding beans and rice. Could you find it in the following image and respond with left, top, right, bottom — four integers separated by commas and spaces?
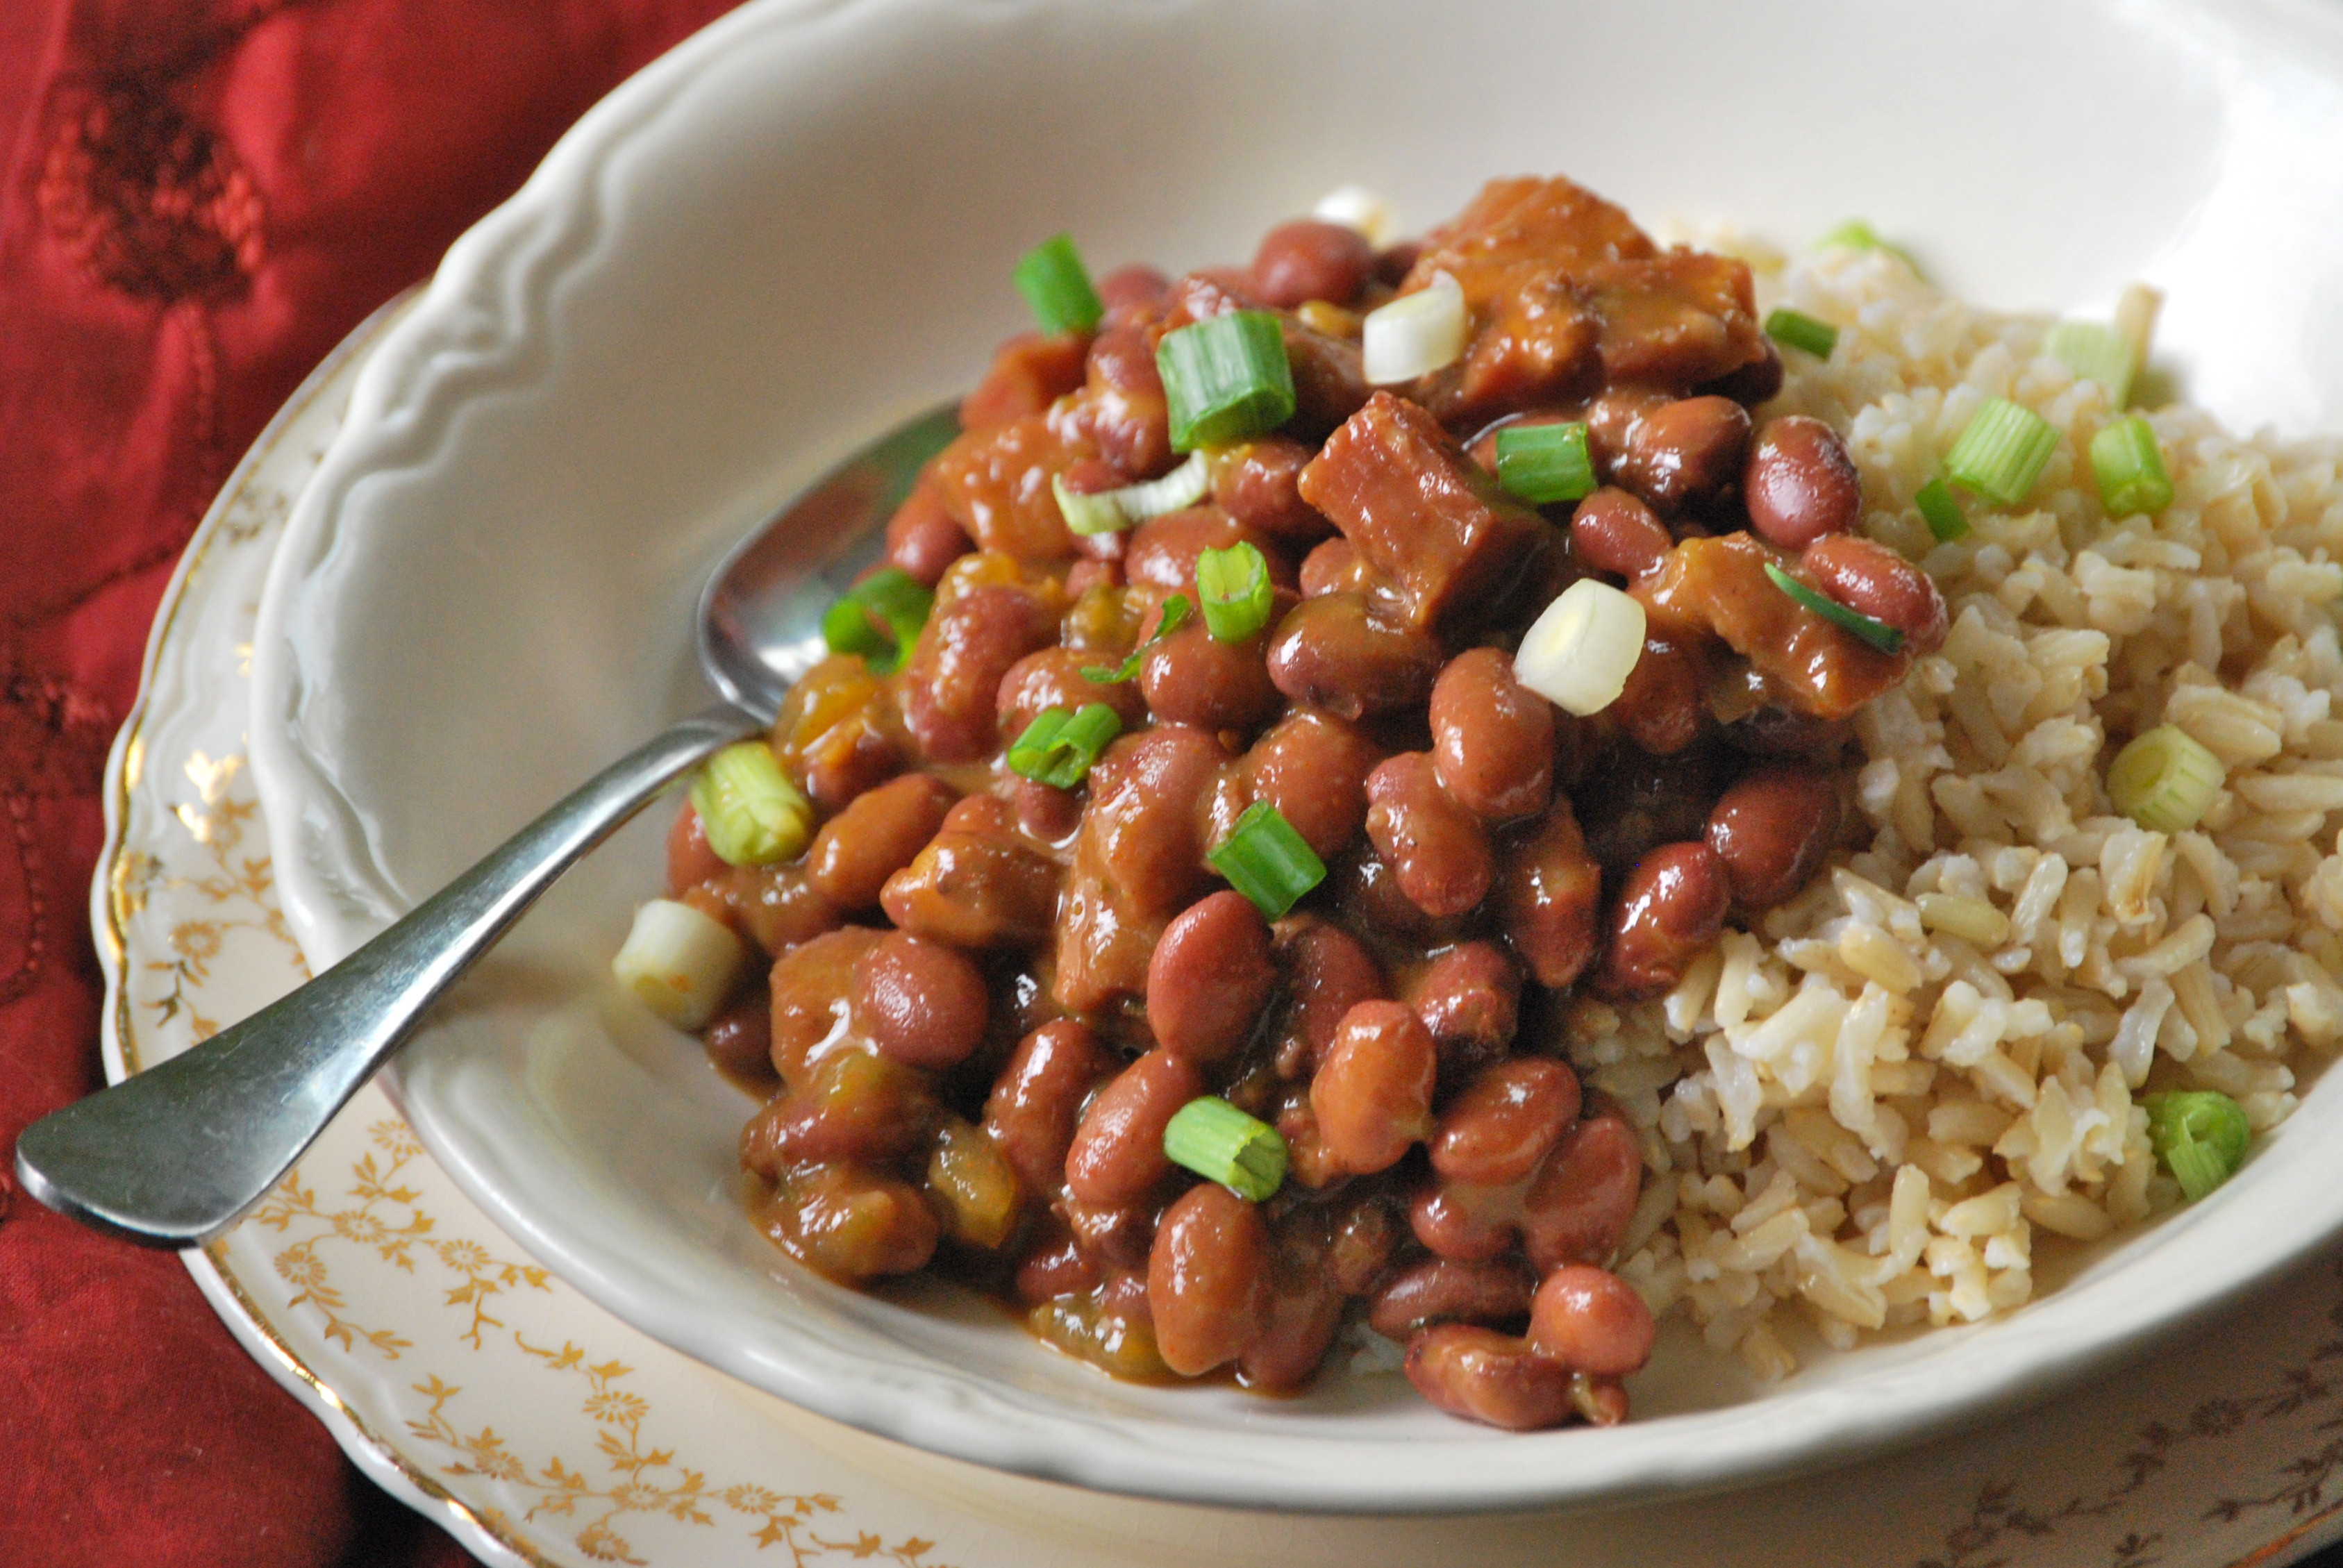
251, 0, 2343, 1510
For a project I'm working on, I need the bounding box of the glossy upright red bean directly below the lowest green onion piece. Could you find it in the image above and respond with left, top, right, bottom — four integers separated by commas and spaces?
1148, 1181, 1270, 1378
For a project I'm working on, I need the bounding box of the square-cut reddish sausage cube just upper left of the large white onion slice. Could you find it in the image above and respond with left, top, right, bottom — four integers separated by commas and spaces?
1301, 392, 1549, 626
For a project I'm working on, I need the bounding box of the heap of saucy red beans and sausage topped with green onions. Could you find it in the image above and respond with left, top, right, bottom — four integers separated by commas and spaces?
642, 178, 1944, 1430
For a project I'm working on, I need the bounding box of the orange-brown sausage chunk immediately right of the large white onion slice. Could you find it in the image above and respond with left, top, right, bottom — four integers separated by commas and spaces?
1628, 535, 1912, 719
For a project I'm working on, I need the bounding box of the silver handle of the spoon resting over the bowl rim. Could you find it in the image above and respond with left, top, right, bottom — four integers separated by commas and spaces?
17, 706, 762, 1247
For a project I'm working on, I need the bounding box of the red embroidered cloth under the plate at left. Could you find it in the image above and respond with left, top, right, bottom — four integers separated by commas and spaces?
0, 0, 731, 1568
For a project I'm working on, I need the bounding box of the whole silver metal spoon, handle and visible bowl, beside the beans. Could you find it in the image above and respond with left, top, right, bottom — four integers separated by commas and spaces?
17, 406, 958, 1247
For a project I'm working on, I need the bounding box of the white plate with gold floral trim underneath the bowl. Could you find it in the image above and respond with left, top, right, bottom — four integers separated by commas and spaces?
92, 277, 2343, 1568
